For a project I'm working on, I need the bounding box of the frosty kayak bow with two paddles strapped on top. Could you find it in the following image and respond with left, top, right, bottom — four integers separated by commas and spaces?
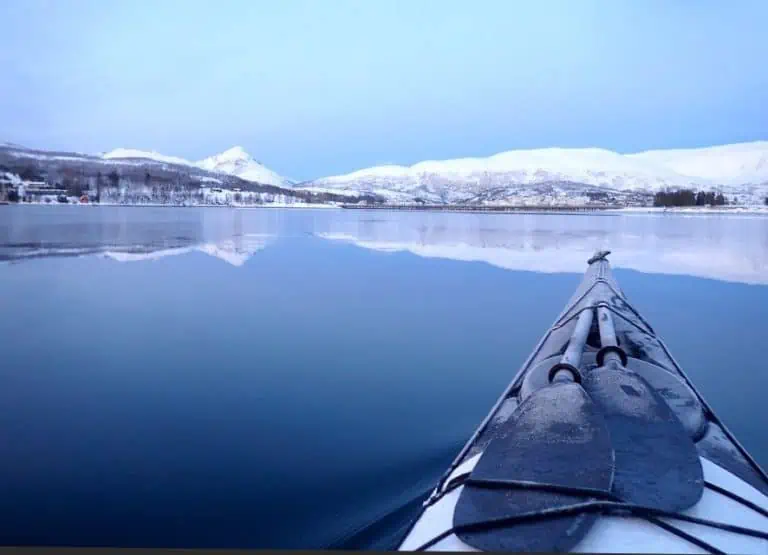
399, 251, 768, 554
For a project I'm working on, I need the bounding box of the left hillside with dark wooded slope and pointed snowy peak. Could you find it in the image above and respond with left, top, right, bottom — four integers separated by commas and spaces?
0, 144, 368, 206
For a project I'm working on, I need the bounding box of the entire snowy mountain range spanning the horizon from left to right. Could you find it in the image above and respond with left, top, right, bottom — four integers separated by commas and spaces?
6, 141, 768, 205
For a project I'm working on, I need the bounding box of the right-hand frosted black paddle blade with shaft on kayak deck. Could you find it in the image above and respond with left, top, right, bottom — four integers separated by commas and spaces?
582, 306, 704, 512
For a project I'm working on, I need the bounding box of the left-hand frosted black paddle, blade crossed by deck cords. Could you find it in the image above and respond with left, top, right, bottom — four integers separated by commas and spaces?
453, 309, 613, 551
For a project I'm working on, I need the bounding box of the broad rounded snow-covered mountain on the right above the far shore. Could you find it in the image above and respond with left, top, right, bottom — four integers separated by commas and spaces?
303, 141, 768, 202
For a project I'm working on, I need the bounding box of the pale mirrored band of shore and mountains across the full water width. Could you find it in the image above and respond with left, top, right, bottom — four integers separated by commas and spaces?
0, 207, 768, 284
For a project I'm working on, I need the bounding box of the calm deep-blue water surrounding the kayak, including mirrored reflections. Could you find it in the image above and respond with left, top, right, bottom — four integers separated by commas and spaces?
0, 206, 768, 547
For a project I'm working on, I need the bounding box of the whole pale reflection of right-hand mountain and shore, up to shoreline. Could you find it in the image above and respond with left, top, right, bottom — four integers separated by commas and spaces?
316, 214, 768, 284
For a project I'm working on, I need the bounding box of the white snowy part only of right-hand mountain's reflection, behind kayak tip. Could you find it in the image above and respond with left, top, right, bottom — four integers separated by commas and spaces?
315, 233, 768, 285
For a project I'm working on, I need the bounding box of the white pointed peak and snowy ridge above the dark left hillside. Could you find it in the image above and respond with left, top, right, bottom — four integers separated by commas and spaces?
102, 146, 291, 187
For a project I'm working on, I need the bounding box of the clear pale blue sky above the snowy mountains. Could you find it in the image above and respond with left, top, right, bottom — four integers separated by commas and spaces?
0, 0, 768, 179
